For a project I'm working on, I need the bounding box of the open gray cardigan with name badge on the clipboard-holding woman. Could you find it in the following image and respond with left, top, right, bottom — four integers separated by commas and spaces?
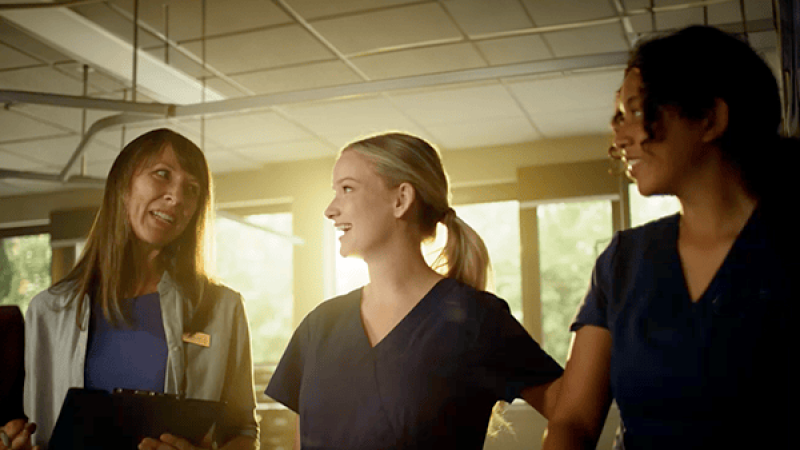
24, 272, 258, 448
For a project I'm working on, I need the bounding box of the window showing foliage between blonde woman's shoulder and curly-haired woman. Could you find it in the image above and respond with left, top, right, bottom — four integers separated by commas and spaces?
536, 201, 612, 364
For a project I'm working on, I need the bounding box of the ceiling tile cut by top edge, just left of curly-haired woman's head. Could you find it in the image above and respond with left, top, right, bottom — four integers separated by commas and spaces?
522, 0, 617, 27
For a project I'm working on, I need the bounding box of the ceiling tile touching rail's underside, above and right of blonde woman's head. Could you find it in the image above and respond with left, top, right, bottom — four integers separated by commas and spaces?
391, 84, 524, 128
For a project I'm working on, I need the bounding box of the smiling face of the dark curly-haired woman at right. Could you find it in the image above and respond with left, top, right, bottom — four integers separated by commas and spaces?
612, 69, 703, 195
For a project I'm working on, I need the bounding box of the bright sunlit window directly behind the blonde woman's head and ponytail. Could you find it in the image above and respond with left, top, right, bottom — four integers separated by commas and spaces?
334, 201, 522, 321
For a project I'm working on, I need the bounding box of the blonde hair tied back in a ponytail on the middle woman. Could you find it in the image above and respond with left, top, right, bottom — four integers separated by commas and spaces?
342, 133, 489, 290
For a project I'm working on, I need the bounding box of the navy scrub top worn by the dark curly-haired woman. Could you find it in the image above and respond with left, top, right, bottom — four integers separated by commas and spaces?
572, 209, 796, 450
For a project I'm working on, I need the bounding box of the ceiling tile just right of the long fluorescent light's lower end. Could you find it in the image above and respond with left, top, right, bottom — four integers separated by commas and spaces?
231, 61, 363, 94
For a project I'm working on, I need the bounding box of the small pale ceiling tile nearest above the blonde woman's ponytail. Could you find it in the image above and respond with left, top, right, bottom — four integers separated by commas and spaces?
425, 117, 540, 150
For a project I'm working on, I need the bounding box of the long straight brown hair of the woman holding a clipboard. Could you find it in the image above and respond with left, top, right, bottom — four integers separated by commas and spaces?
50, 128, 213, 326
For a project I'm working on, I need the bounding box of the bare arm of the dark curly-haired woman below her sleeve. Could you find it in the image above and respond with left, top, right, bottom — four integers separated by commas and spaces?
542, 325, 611, 450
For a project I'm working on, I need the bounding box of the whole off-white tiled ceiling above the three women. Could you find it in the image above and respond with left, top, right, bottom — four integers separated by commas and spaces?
0, 0, 777, 196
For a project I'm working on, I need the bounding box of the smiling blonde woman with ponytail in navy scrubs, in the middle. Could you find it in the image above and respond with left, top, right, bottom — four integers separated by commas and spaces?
266, 133, 561, 450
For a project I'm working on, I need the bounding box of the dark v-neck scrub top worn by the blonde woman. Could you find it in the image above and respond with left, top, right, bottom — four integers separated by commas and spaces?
266, 279, 562, 450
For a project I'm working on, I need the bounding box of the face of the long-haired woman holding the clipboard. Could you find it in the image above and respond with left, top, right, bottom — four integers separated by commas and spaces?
125, 146, 201, 255
